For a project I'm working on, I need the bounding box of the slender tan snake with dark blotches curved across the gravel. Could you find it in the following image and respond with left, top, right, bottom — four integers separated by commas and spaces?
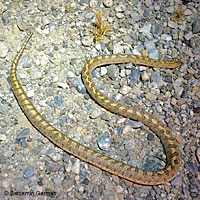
10, 32, 183, 185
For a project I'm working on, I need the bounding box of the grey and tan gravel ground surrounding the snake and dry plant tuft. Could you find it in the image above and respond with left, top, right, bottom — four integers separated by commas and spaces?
0, 0, 200, 200
